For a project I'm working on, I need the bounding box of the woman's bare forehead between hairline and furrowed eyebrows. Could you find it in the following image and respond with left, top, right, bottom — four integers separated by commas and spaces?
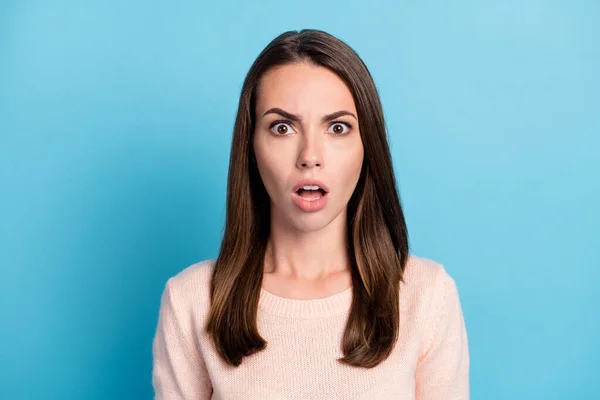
256, 63, 356, 114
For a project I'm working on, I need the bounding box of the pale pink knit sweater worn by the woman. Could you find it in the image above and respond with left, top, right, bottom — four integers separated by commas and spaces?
152, 255, 469, 400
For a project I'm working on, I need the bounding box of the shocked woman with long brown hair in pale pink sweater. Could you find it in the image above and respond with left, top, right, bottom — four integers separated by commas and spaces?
152, 30, 469, 400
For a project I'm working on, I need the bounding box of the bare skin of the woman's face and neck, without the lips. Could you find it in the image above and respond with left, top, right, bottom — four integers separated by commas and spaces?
253, 63, 364, 299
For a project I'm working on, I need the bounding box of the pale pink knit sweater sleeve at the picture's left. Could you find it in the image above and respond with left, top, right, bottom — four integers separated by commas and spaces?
152, 278, 212, 400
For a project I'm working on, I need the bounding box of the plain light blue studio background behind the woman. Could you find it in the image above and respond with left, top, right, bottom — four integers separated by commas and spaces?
0, 0, 600, 400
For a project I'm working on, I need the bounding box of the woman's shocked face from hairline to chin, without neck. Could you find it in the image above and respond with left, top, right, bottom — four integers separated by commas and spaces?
253, 63, 364, 231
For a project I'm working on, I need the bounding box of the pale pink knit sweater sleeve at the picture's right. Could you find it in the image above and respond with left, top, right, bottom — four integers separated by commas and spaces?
415, 267, 469, 400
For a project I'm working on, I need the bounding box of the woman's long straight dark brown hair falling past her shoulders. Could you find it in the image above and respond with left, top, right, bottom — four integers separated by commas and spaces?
206, 29, 409, 368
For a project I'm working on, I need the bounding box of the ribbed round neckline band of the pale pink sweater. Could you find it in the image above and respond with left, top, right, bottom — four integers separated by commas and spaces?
258, 286, 352, 318
